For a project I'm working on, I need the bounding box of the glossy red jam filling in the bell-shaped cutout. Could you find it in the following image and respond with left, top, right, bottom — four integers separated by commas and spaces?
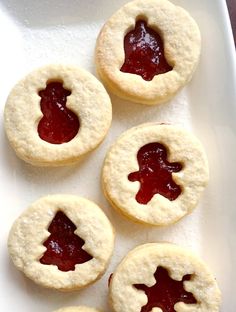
120, 20, 173, 81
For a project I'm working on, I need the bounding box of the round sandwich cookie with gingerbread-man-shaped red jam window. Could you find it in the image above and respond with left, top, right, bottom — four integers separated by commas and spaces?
102, 123, 209, 226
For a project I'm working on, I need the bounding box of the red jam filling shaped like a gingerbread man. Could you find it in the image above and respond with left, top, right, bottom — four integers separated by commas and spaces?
128, 143, 182, 205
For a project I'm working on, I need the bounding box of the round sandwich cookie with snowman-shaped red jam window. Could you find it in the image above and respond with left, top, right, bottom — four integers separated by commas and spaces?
4, 65, 112, 166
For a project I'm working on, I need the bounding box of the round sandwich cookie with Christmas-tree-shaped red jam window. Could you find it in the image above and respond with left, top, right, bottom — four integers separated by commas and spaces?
8, 195, 114, 291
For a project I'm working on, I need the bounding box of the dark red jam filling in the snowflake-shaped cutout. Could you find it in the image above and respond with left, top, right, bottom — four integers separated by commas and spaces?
134, 267, 197, 312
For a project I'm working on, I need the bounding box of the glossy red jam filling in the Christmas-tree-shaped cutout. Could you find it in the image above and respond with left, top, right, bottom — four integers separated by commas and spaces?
40, 211, 92, 272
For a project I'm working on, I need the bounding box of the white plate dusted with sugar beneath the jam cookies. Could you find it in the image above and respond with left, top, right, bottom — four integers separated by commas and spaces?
0, 0, 236, 312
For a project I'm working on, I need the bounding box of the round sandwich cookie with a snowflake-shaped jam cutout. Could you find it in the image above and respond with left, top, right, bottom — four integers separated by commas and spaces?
109, 243, 221, 312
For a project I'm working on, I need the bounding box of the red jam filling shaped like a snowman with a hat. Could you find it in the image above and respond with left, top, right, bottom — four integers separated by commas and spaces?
38, 82, 80, 144
